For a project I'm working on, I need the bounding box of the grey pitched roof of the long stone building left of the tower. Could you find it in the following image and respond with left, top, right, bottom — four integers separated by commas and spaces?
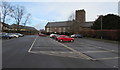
46, 21, 73, 27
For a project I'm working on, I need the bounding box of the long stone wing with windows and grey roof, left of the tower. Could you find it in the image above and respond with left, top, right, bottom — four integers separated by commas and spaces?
45, 21, 73, 33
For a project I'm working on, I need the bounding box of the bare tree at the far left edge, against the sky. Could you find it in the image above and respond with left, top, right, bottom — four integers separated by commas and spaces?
0, 2, 12, 23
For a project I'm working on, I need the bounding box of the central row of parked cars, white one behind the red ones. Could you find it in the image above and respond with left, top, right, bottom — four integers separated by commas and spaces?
50, 34, 75, 42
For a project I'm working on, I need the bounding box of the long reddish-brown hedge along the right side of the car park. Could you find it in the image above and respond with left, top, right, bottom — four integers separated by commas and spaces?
80, 30, 119, 40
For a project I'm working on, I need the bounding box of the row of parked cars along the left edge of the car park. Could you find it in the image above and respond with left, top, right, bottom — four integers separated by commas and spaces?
0, 33, 24, 39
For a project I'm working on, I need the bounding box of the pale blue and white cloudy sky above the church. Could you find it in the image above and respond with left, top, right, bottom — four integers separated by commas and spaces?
7, 1, 118, 30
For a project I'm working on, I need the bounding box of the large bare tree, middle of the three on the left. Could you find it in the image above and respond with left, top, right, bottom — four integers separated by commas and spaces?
11, 5, 25, 30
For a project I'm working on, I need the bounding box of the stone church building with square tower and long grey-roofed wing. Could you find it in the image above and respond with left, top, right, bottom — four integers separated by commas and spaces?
45, 9, 94, 34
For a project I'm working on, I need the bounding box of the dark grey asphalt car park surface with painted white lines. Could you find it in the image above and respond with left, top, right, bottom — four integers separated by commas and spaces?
2, 35, 119, 68
